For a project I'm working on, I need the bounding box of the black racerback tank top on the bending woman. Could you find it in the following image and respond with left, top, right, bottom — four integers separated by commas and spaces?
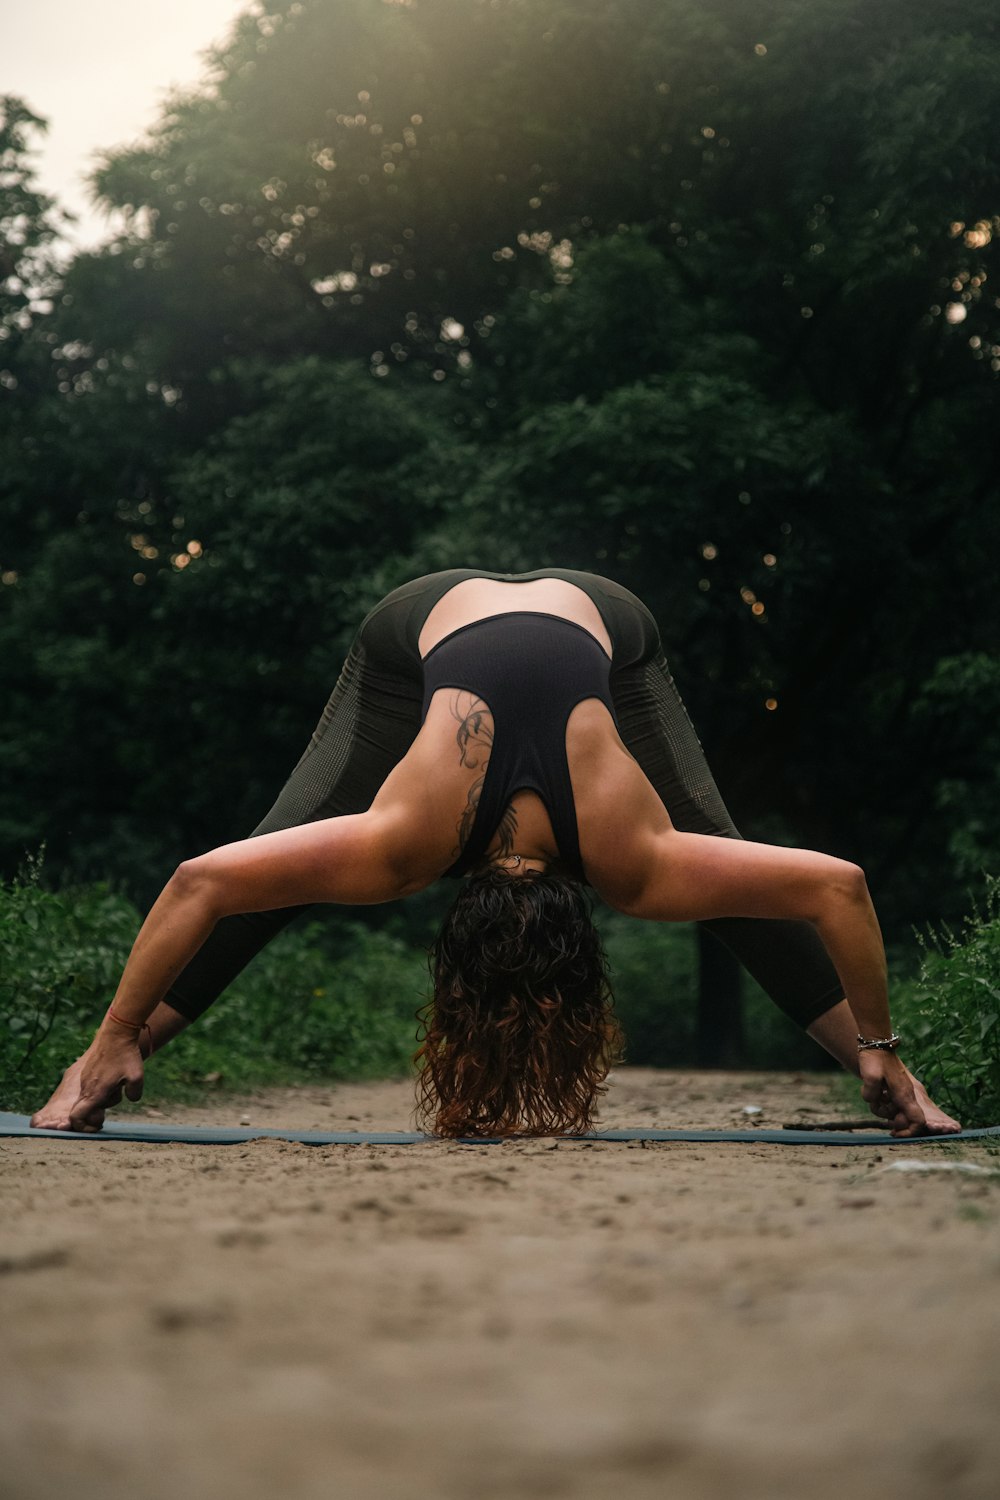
421, 611, 615, 881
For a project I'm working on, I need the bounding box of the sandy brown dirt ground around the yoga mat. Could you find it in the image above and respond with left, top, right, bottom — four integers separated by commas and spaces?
0, 1070, 1000, 1500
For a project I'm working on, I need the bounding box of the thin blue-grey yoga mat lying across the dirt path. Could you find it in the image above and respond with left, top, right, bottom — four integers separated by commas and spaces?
0, 1113, 1000, 1146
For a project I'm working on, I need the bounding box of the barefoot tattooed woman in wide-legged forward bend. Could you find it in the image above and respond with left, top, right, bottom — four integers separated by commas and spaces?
33, 569, 960, 1136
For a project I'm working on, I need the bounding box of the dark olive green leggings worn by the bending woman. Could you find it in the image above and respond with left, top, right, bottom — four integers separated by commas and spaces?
165, 569, 844, 1028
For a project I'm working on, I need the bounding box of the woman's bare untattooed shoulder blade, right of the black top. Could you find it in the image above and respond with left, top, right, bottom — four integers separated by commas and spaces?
567, 701, 673, 911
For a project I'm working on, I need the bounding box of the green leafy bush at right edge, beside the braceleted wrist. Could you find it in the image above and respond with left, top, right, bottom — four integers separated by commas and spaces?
892, 879, 1000, 1128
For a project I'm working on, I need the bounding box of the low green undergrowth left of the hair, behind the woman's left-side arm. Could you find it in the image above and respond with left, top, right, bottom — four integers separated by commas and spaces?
0, 866, 427, 1110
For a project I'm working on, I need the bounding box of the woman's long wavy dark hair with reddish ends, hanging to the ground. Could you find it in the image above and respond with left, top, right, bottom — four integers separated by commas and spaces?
415, 870, 622, 1137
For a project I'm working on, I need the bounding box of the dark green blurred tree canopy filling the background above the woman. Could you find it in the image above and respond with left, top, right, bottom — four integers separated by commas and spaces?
0, 0, 1000, 935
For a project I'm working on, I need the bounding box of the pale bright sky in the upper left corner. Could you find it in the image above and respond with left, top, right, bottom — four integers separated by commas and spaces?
0, 0, 252, 246
